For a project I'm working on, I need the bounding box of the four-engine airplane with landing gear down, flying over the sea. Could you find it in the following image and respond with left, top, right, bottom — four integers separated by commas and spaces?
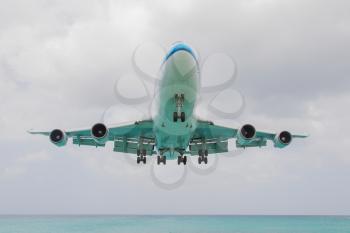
28, 42, 307, 165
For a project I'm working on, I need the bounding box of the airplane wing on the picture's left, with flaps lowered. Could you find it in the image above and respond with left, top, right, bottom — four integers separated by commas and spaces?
28, 120, 155, 155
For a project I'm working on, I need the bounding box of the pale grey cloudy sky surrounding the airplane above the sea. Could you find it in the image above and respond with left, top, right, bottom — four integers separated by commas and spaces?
0, 0, 350, 215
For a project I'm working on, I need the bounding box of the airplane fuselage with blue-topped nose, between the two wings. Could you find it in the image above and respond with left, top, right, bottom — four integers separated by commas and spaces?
154, 44, 199, 159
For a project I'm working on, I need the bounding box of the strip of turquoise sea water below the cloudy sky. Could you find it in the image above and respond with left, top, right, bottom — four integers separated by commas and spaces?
0, 216, 350, 233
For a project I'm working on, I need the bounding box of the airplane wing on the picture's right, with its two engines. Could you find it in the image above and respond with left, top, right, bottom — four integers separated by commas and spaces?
190, 121, 308, 155
